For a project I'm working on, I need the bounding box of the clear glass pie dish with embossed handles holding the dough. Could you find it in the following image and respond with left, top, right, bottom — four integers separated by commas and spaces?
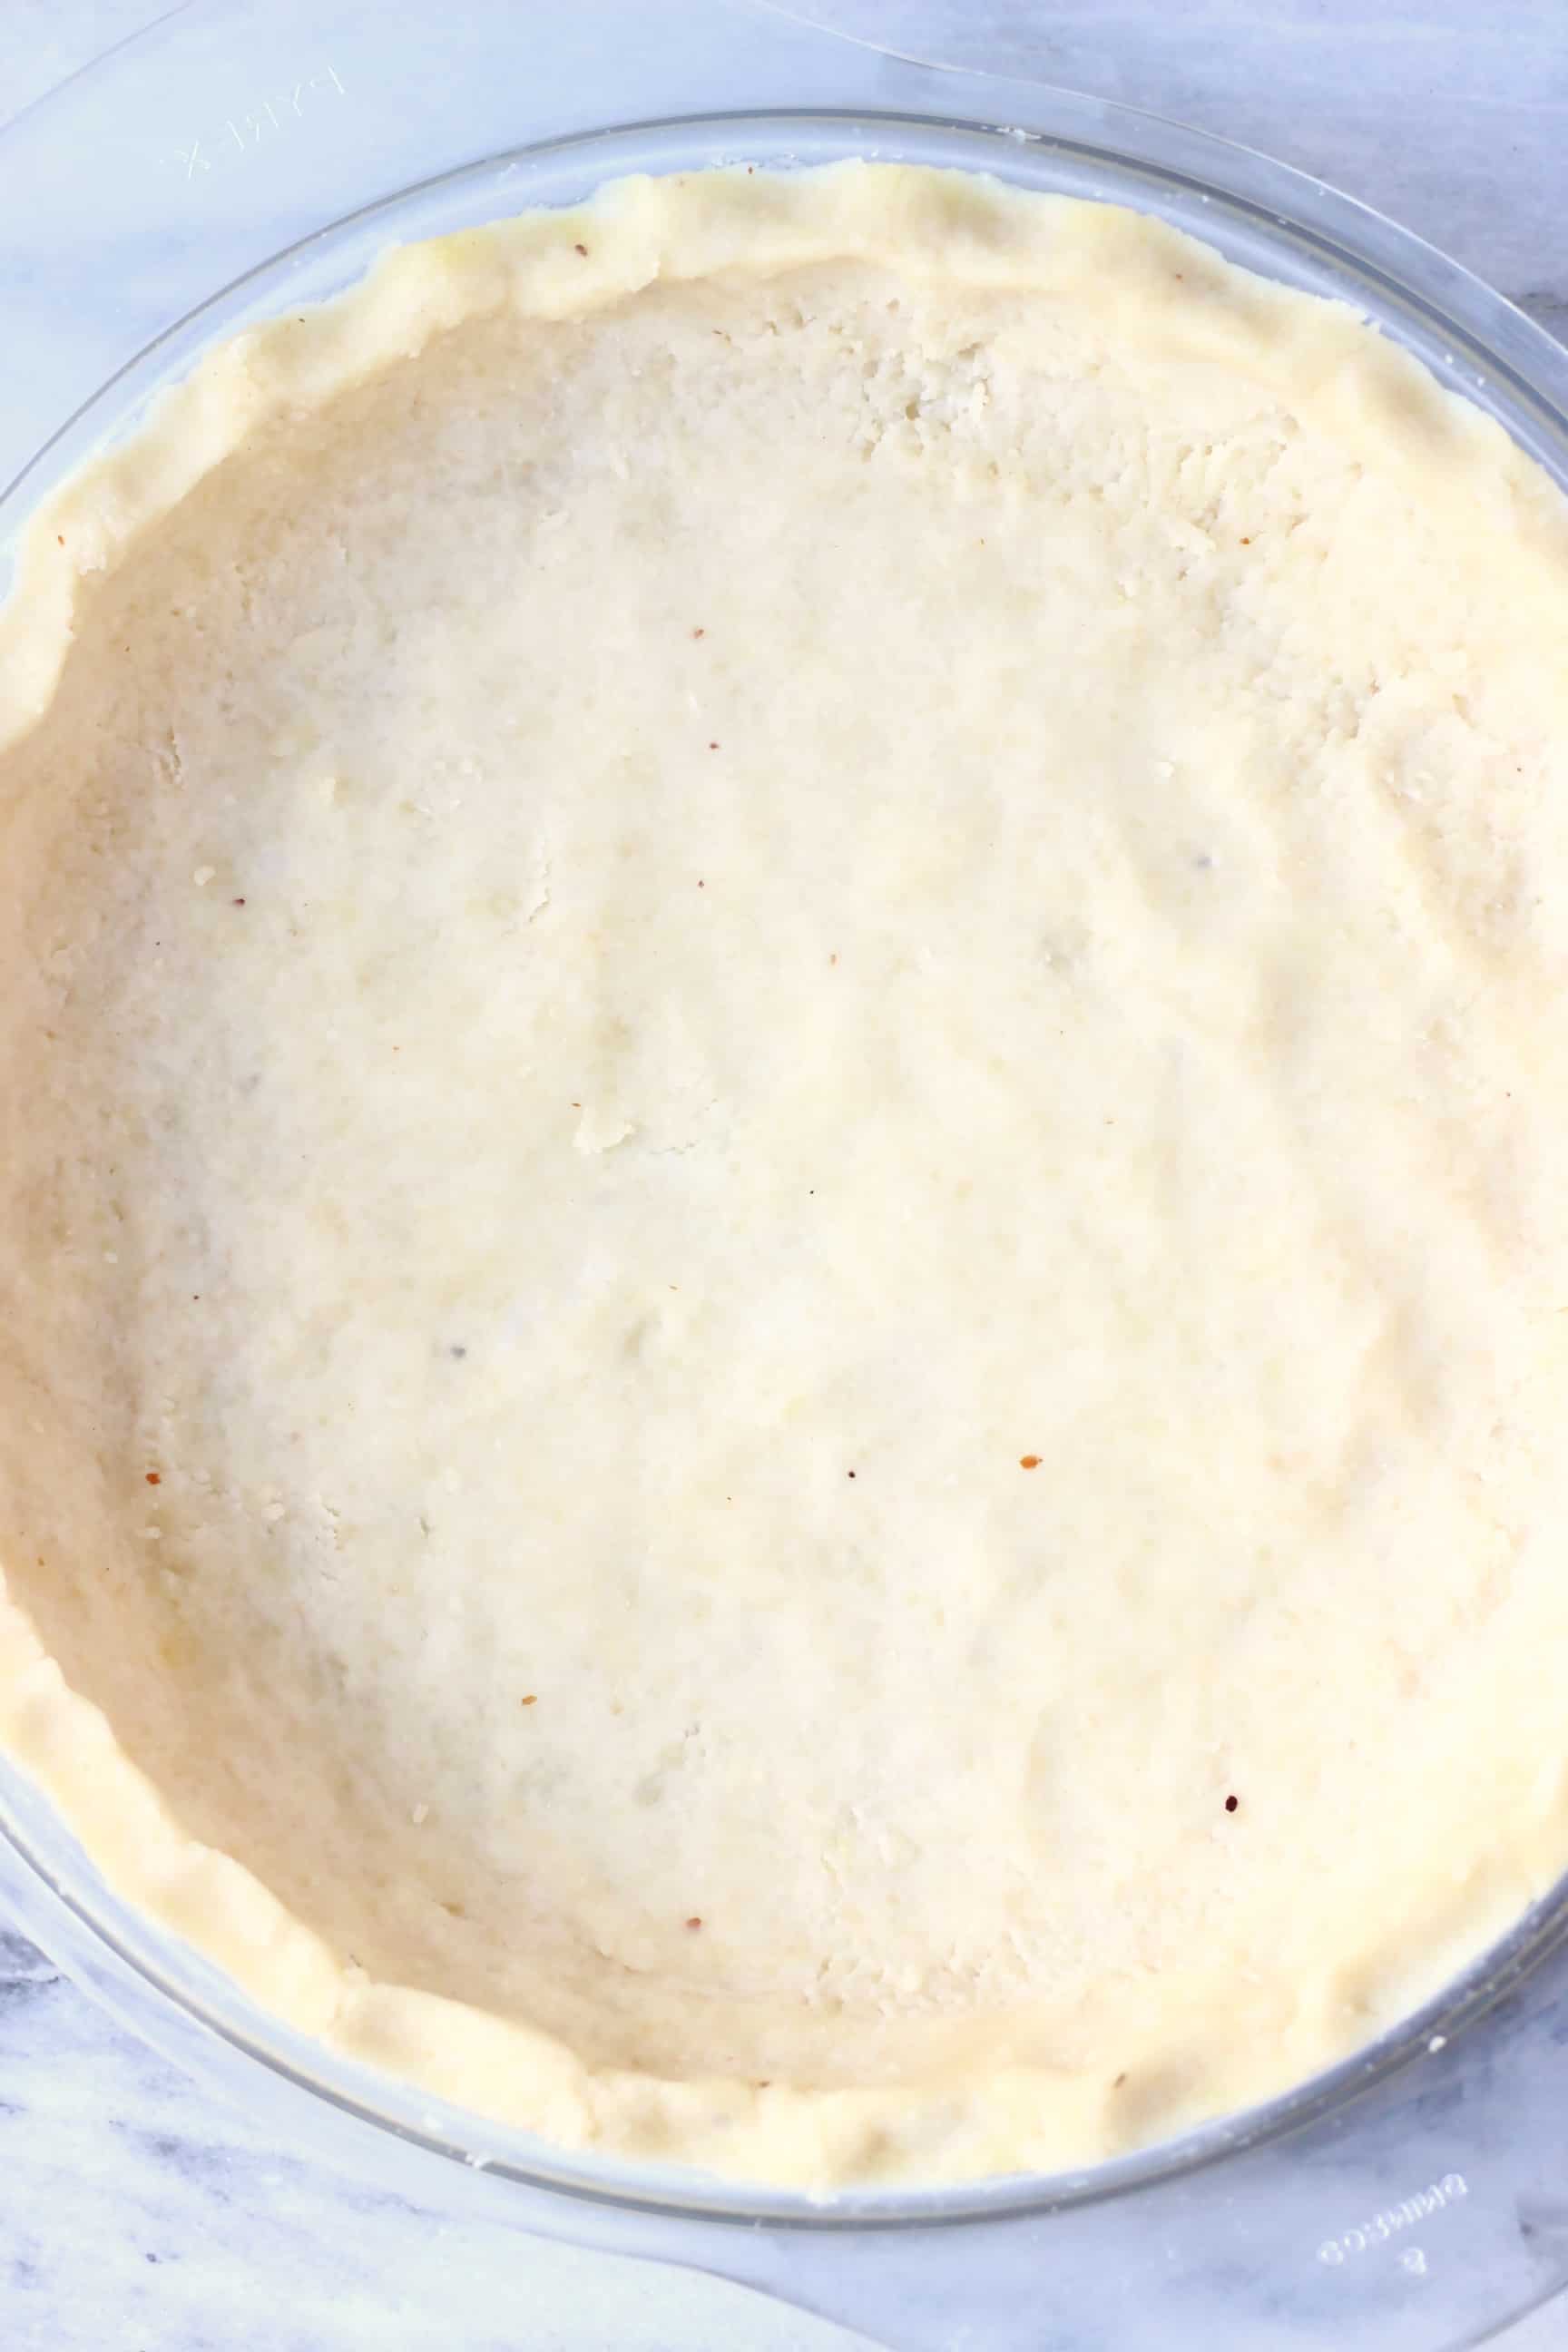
0, 0, 1568, 2352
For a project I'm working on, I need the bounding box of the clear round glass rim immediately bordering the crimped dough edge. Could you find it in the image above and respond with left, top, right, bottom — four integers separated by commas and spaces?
0, 74, 1568, 2232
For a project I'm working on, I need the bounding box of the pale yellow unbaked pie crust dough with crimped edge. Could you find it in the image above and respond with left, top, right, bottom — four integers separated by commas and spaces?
0, 167, 1568, 2188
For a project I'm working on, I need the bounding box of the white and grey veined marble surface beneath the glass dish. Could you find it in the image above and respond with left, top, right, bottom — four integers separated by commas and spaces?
0, 0, 1568, 2352
